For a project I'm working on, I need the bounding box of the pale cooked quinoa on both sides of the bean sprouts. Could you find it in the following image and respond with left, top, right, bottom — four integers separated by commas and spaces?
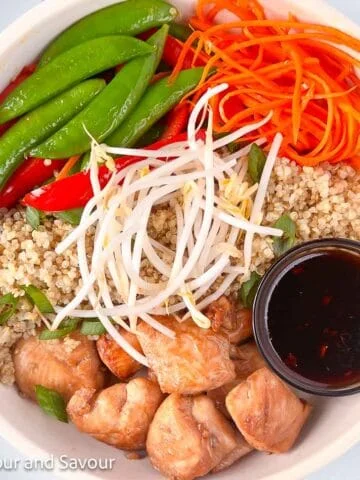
0, 159, 360, 384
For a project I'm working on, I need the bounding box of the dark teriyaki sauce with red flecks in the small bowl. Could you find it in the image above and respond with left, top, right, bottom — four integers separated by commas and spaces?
267, 250, 360, 387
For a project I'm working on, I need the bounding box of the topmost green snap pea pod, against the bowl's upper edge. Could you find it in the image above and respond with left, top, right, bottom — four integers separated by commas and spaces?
40, 0, 178, 66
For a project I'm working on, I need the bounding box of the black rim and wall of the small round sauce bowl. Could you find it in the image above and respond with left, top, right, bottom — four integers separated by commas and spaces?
253, 238, 360, 396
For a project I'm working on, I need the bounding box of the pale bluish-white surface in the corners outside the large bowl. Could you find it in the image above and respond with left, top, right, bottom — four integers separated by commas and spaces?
0, 0, 360, 480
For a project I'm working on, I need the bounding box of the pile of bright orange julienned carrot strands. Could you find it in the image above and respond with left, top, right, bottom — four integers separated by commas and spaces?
172, 0, 360, 168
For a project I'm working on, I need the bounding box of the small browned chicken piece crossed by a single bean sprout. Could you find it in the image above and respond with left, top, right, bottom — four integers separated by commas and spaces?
96, 329, 142, 380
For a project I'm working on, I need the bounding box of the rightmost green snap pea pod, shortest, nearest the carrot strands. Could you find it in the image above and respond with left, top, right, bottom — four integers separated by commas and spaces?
106, 67, 203, 147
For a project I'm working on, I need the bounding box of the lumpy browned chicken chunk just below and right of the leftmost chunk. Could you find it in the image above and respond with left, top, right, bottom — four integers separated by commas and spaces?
67, 378, 163, 450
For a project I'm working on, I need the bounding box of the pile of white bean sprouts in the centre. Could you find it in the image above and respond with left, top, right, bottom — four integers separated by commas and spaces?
52, 84, 283, 365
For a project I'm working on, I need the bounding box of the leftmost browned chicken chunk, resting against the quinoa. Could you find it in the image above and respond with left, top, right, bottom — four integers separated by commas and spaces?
13, 332, 104, 401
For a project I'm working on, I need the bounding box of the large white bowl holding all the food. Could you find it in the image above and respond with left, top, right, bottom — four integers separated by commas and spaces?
0, 0, 360, 480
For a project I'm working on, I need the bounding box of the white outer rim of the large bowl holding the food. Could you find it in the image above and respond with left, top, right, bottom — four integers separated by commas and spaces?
0, 0, 360, 480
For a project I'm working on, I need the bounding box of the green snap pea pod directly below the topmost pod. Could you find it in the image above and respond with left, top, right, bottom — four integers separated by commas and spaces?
0, 36, 153, 124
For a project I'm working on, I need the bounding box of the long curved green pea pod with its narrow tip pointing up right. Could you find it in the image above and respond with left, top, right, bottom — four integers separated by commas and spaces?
30, 25, 169, 158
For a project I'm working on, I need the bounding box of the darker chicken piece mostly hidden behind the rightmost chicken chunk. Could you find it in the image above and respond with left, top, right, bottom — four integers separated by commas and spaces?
208, 342, 266, 418
